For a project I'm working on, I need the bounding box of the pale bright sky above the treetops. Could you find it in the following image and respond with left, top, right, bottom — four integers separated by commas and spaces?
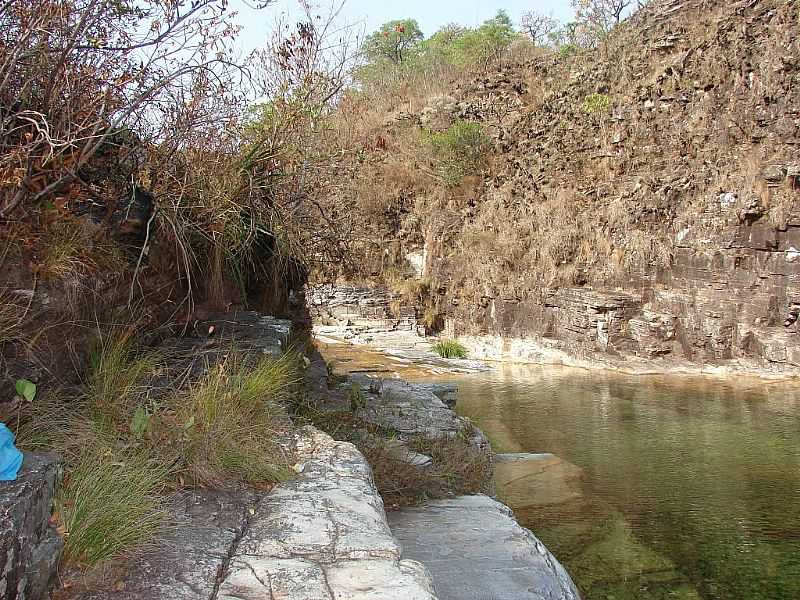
230, 0, 572, 51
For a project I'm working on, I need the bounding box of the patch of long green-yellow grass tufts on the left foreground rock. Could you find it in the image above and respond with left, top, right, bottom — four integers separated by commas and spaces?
18, 335, 297, 567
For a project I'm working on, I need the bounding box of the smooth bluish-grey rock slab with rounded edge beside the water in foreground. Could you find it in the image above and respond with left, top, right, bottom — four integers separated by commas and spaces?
389, 496, 579, 600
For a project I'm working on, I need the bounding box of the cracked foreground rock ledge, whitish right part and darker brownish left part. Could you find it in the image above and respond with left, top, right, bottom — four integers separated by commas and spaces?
81, 427, 436, 600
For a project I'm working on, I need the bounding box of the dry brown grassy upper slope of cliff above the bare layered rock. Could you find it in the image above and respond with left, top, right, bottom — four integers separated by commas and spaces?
310, 0, 800, 336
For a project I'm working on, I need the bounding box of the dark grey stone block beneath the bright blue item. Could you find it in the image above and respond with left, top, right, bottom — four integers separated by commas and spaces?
0, 454, 63, 600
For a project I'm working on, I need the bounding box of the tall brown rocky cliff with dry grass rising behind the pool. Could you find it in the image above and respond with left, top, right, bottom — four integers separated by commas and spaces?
342, 0, 800, 374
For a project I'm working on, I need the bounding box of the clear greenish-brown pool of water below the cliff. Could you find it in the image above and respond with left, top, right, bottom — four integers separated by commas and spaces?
444, 367, 800, 600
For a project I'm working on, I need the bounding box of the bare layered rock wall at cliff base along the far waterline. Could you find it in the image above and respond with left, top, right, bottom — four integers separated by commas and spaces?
449, 222, 800, 374
